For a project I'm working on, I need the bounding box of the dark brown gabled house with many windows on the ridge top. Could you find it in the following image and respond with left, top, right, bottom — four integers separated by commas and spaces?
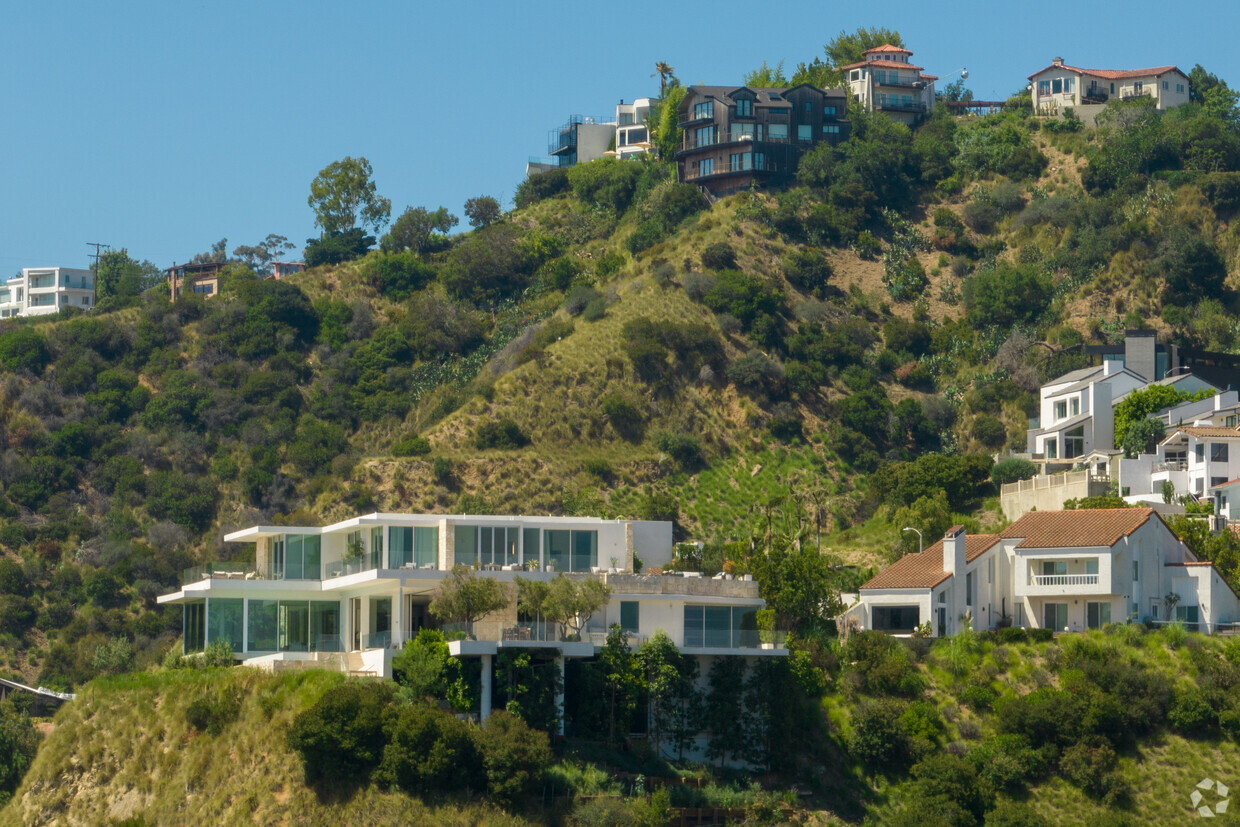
676, 83, 849, 196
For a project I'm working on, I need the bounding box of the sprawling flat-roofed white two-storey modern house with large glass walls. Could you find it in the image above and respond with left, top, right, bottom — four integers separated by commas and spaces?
159, 513, 787, 717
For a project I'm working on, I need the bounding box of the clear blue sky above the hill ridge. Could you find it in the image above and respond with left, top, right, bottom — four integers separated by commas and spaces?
0, 0, 1240, 275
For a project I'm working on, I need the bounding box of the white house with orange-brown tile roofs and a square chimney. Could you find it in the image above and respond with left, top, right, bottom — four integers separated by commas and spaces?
847, 508, 1240, 636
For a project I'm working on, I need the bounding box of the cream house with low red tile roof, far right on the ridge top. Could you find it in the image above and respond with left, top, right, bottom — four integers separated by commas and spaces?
1029, 57, 1188, 115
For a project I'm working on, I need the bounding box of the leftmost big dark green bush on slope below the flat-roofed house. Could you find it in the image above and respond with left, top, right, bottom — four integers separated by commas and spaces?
288, 681, 392, 784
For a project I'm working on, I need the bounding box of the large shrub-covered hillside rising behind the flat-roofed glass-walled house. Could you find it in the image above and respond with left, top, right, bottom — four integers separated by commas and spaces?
0, 77, 1240, 687
